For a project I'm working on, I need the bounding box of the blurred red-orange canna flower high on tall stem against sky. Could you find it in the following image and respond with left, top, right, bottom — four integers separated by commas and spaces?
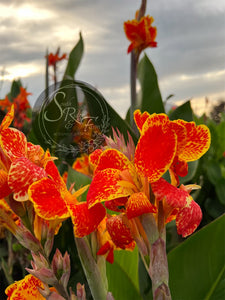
124, 16, 157, 54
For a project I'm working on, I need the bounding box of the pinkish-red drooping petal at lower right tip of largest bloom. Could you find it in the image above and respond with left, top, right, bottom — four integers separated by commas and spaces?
176, 196, 202, 237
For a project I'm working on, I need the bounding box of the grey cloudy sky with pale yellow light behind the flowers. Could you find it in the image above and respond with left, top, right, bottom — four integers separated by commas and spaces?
0, 0, 225, 116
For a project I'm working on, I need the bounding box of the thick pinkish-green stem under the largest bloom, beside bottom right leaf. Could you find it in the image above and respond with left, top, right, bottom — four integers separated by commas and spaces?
141, 213, 171, 300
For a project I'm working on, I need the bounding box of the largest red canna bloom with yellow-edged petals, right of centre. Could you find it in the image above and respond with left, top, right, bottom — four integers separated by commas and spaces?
87, 110, 210, 240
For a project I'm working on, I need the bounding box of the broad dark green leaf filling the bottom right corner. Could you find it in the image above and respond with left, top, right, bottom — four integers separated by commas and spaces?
168, 215, 225, 300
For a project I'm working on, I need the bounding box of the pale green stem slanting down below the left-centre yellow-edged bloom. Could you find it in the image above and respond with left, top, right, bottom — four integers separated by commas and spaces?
75, 237, 107, 300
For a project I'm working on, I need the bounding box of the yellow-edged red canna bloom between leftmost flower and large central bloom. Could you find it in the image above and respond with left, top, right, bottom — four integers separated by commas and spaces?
28, 161, 105, 237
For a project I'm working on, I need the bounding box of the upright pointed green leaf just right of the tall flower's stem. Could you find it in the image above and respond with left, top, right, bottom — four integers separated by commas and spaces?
137, 54, 165, 113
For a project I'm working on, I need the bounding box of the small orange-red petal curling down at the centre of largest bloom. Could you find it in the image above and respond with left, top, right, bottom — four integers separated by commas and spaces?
126, 192, 157, 219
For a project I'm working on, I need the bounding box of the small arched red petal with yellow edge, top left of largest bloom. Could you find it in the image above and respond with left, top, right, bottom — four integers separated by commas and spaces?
95, 149, 131, 173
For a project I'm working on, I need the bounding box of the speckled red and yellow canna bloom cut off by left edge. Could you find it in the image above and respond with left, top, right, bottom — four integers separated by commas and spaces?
0, 106, 52, 201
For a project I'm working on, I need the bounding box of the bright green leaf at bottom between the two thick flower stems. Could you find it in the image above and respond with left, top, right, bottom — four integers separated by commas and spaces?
107, 247, 141, 300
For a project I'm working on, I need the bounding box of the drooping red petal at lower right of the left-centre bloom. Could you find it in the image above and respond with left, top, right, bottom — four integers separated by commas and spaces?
67, 202, 106, 237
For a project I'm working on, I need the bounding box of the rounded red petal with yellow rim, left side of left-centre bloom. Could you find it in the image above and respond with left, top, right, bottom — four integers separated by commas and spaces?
28, 178, 69, 220
